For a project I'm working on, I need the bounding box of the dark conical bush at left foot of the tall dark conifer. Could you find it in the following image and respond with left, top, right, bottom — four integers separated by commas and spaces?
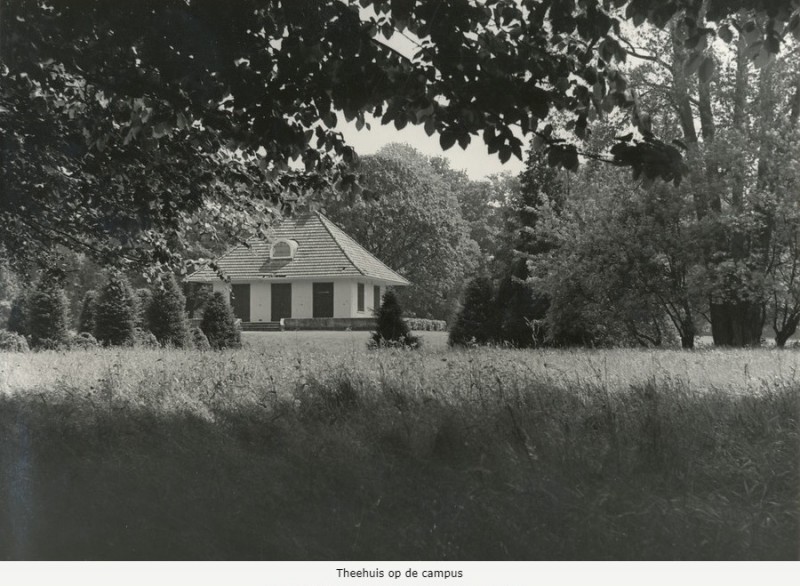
448, 277, 499, 346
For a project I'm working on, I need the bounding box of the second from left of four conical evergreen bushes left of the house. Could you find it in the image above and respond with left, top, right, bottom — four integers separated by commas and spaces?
94, 274, 136, 346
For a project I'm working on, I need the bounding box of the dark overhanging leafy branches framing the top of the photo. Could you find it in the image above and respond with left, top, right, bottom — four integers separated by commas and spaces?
0, 0, 800, 263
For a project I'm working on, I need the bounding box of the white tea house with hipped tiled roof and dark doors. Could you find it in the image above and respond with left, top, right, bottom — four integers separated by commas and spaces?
186, 212, 409, 329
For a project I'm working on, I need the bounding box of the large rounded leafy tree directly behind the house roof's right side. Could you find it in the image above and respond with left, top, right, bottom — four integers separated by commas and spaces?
325, 144, 478, 320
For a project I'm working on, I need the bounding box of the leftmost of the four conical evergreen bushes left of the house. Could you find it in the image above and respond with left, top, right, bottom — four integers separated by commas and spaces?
27, 278, 69, 349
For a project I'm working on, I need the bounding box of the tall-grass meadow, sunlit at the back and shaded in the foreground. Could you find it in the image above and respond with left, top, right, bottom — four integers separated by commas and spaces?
0, 332, 800, 560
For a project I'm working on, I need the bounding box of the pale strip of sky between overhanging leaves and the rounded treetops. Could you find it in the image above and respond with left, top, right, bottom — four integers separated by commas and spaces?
337, 114, 526, 180
